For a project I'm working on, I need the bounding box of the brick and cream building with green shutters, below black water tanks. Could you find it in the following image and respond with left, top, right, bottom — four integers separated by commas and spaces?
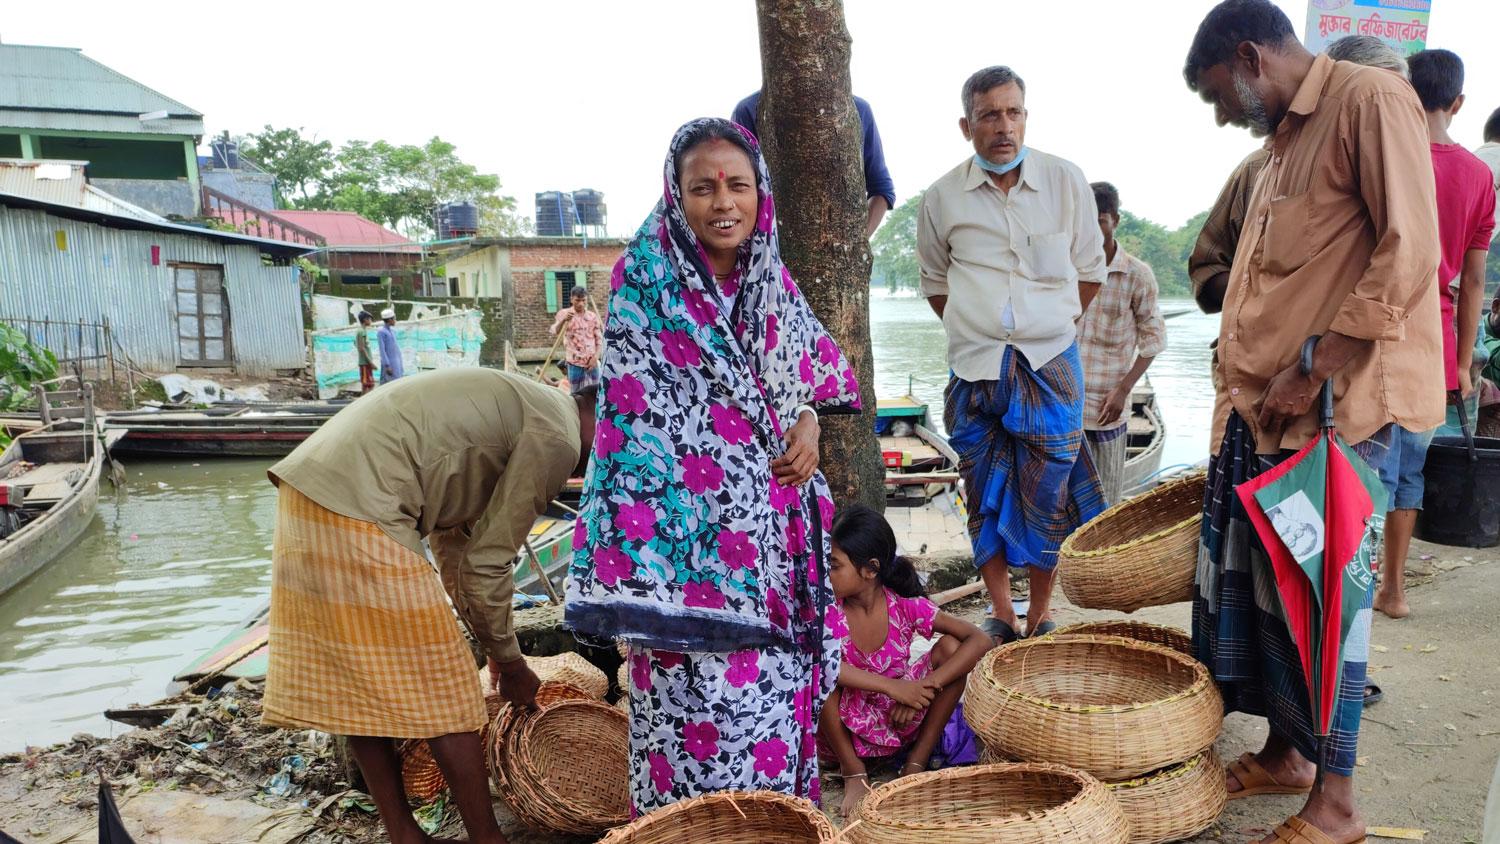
440, 237, 627, 363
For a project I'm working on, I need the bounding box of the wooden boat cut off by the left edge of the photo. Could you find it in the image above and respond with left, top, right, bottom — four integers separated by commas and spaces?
0, 391, 104, 595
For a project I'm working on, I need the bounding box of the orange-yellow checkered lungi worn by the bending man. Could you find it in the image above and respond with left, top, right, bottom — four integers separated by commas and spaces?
263, 483, 486, 739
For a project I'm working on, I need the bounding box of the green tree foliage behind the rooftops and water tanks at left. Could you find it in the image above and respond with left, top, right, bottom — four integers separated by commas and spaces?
242, 126, 531, 238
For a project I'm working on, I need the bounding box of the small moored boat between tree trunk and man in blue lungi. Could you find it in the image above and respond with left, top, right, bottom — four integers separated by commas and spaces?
875, 396, 959, 507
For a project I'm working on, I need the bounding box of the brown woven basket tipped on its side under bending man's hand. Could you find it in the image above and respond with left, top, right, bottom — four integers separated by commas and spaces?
492, 700, 630, 835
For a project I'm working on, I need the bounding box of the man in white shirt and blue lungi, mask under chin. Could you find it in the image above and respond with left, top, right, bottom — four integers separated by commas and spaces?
917, 66, 1107, 643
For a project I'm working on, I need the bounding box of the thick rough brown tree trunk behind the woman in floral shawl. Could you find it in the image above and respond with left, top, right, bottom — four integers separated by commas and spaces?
756, 0, 885, 510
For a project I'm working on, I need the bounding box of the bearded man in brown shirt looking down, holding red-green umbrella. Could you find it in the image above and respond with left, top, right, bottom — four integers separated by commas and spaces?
1184, 0, 1443, 844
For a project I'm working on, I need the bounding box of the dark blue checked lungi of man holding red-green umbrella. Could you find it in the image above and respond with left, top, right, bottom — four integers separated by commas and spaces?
1193, 412, 1394, 777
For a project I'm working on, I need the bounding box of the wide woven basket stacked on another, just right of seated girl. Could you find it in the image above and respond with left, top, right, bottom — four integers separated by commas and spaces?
963, 636, 1224, 780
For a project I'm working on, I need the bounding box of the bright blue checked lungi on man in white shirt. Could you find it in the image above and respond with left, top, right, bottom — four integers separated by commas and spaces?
944, 343, 1104, 571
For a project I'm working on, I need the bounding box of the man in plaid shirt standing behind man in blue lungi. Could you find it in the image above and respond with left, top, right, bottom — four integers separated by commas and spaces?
1079, 181, 1167, 505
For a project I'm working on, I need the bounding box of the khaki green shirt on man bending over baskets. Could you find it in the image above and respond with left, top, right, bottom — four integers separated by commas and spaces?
269, 367, 579, 661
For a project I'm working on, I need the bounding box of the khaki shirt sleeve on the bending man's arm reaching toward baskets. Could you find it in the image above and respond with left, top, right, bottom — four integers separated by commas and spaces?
444, 432, 578, 663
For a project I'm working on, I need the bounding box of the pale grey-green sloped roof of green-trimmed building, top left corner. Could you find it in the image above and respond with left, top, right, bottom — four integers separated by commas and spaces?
0, 43, 203, 135
